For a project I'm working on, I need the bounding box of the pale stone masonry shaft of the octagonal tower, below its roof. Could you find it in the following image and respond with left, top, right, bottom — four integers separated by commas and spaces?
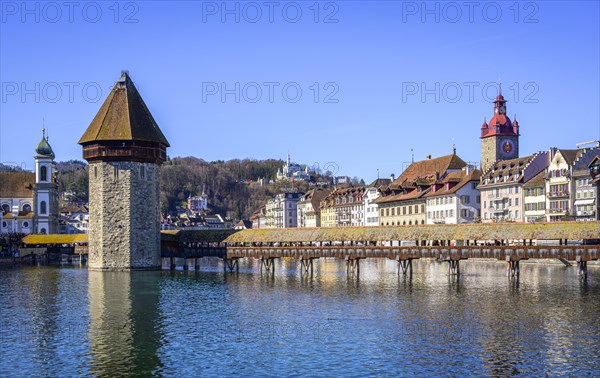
88, 162, 161, 270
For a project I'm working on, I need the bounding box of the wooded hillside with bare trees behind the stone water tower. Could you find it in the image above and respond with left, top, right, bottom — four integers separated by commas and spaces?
57, 157, 342, 220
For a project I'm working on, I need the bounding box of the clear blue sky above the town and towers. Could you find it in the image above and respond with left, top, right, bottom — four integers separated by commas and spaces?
0, 1, 600, 181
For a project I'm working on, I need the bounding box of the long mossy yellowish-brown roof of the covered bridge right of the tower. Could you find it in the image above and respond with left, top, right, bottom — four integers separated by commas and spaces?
224, 222, 600, 243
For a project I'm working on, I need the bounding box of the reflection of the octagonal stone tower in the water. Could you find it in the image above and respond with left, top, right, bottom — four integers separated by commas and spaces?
88, 271, 162, 376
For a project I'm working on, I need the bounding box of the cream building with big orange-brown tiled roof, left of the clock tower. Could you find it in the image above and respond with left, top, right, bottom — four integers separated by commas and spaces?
375, 153, 467, 226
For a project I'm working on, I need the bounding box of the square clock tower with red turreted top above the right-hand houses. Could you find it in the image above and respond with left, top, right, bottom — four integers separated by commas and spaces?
481, 92, 519, 172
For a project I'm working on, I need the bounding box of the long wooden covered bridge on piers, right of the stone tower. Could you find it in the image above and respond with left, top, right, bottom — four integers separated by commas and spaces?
163, 222, 600, 277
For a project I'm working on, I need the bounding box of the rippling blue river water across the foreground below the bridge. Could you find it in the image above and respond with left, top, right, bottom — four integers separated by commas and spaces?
0, 259, 600, 377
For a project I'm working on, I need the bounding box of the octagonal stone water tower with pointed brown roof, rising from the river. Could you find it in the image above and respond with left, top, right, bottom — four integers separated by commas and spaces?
78, 71, 169, 270
